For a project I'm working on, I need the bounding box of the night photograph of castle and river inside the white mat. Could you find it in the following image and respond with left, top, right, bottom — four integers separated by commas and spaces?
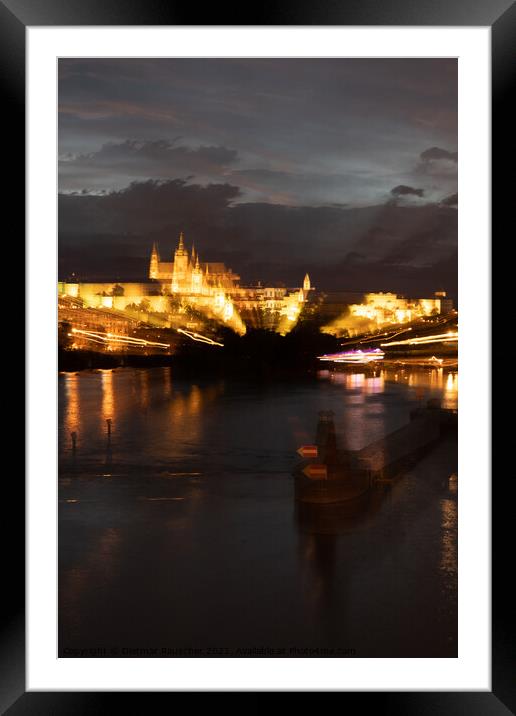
57, 57, 459, 658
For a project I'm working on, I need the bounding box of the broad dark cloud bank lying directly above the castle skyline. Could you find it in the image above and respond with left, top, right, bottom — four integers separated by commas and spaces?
59, 180, 457, 300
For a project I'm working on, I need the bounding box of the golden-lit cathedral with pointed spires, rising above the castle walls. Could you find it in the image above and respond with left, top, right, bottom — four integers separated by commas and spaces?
149, 232, 240, 295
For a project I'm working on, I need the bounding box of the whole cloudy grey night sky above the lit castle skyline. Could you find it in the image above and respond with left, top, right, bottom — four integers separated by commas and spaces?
59, 59, 457, 295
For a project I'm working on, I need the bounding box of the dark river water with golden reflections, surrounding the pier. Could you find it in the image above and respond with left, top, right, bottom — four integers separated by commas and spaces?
58, 368, 457, 657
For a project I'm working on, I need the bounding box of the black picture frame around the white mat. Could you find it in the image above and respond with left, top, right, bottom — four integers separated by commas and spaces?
4, 0, 510, 704
